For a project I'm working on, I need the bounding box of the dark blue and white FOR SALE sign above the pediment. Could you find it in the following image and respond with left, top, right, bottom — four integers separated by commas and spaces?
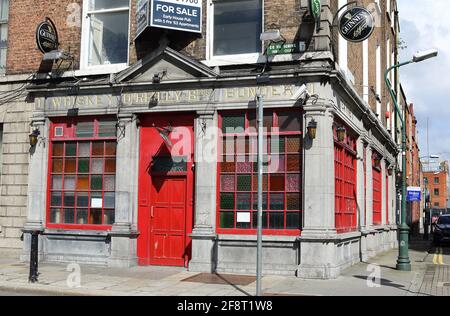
150, 0, 202, 33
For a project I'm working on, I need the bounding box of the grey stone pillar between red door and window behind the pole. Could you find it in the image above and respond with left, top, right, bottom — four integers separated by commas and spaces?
189, 111, 218, 273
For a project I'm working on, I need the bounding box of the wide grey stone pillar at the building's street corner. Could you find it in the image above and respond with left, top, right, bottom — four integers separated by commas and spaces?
297, 101, 339, 279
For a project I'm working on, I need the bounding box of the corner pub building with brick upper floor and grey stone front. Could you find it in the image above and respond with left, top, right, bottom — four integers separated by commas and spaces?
0, 0, 418, 279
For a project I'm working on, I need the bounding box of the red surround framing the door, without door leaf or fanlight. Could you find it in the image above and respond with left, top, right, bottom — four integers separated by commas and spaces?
137, 113, 195, 267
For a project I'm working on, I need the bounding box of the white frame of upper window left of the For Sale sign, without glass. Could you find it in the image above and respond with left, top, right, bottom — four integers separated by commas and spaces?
80, 0, 131, 74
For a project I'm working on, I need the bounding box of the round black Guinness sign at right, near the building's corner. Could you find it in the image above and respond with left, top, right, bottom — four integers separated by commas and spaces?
339, 7, 375, 42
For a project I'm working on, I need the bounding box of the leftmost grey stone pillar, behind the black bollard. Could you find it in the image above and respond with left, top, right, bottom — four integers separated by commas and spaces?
21, 115, 49, 260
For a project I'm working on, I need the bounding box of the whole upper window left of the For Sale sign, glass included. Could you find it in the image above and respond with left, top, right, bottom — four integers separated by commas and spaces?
82, 0, 130, 67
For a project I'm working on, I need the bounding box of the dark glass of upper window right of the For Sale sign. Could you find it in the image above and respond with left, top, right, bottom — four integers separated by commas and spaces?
210, 0, 263, 59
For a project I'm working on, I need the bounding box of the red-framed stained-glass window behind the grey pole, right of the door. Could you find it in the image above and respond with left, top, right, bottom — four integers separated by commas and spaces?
217, 110, 302, 234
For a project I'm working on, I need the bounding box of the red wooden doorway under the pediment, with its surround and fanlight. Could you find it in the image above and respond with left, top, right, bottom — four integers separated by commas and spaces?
137, 114, 194, 266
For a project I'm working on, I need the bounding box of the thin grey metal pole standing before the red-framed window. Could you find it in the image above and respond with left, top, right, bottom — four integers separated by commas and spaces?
256, 94, 264, 296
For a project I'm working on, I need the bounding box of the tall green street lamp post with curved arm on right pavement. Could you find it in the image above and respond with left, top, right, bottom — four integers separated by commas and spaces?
385, 61, 413, 271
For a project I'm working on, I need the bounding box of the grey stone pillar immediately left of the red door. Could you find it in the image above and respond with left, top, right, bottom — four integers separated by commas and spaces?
108, 114, 139, 267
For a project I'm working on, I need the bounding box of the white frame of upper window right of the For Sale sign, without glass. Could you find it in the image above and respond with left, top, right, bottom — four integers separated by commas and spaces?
203, 0, 265, 67
